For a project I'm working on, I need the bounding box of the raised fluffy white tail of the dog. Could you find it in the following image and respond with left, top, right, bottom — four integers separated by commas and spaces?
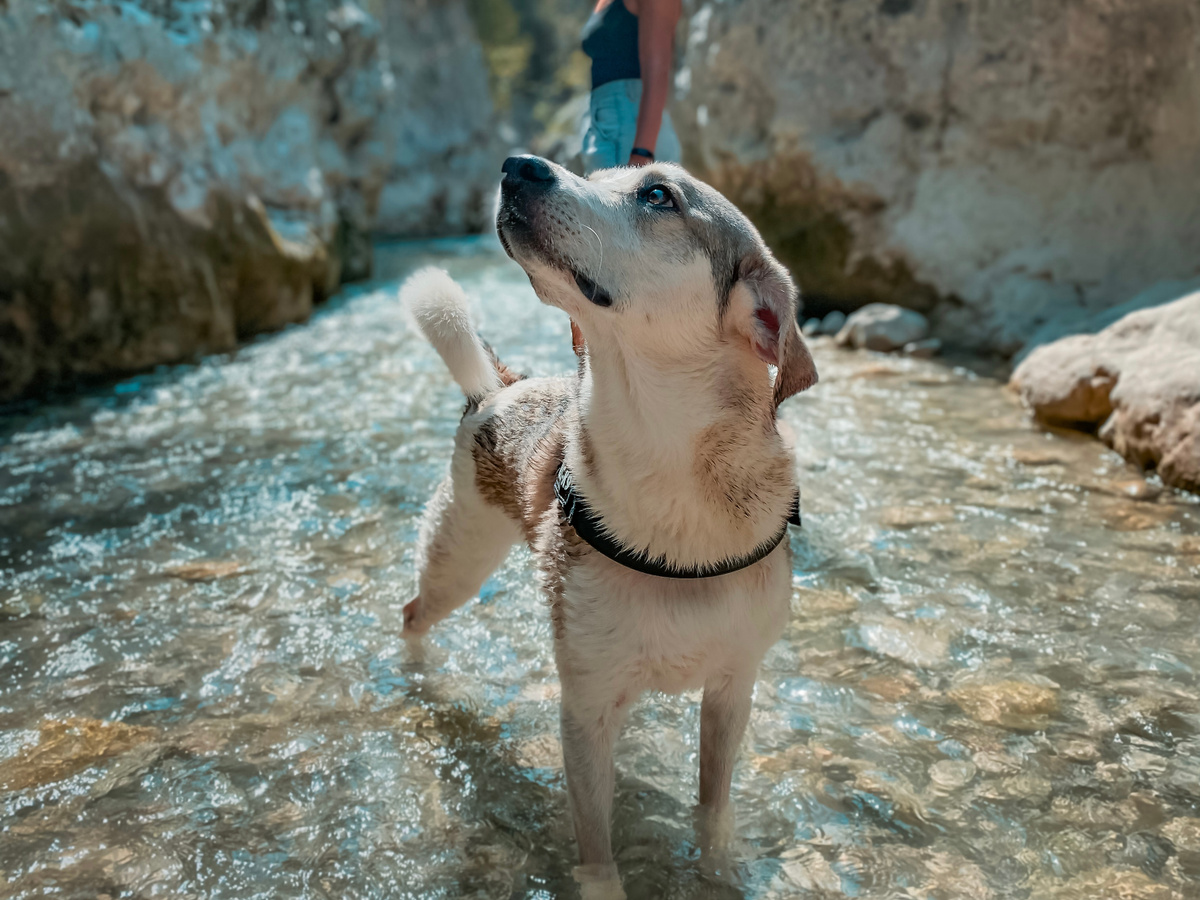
400, 266, 518, 402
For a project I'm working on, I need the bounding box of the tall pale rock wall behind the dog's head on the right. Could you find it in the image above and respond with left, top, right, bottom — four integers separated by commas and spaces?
674, 0, 1200, 354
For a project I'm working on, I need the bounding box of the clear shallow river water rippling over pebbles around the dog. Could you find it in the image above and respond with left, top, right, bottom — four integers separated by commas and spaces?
0, 240, 1200, 900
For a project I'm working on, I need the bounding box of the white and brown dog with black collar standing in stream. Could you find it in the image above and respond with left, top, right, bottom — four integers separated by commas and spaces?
401, 156, 817, 900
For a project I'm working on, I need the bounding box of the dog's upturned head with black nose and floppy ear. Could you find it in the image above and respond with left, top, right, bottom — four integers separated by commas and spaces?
497, 156, 817, 406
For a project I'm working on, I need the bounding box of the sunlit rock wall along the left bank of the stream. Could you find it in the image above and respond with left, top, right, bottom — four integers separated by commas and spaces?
0, 0, 497, 401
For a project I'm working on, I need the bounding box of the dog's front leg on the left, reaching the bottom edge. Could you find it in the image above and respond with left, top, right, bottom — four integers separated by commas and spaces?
562, 696, 625, 900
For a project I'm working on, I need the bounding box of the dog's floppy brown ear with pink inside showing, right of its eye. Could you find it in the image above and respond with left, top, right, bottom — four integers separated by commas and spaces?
733, 244, 817, 407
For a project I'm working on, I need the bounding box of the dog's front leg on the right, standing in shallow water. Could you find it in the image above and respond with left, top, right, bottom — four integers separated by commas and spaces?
698, 670, 756, 851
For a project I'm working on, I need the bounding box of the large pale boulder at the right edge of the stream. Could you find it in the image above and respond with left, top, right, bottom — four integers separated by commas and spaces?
1012, 292, 1200, 491
